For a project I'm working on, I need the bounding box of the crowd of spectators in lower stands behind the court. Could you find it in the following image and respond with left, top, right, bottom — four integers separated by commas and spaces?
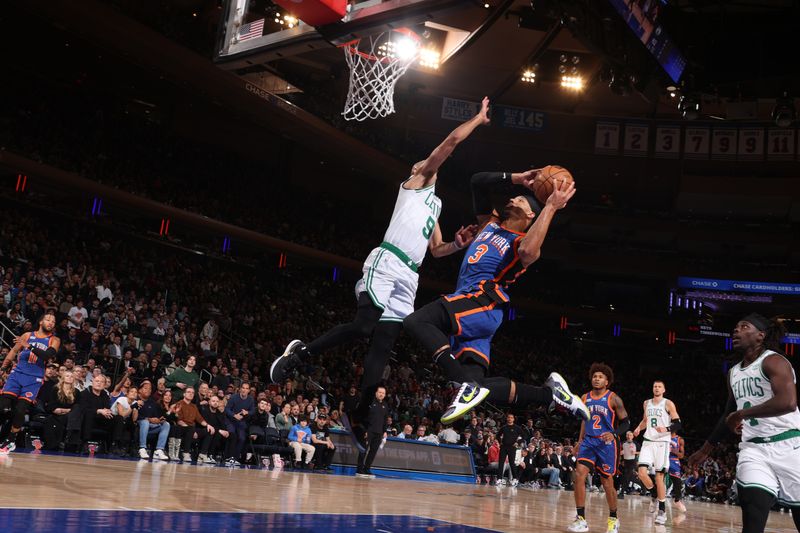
0, 202, 735, 500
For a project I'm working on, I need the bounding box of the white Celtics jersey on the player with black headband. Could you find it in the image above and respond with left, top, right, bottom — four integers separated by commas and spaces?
729, 350, 800, 442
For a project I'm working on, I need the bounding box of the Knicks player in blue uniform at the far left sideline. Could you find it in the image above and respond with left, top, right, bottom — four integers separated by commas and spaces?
0, 311, 61, 454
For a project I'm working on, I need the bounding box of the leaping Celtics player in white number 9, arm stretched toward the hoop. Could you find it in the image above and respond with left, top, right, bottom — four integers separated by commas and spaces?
270, 98, 489, 414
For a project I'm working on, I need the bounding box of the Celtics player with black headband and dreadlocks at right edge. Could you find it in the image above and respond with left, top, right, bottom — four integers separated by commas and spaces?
689, 314, 800, 533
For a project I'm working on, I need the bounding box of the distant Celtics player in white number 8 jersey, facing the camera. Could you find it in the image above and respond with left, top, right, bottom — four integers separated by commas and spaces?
633, 380, 681, 524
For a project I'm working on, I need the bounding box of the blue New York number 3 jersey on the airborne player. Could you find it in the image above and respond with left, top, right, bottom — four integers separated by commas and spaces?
455, 222, 525, 302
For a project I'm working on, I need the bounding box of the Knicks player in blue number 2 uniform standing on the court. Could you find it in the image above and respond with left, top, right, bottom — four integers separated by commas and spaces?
567, 363, 631, 533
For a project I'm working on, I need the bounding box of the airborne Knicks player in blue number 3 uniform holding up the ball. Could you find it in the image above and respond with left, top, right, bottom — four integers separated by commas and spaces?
403, 169, 588, 424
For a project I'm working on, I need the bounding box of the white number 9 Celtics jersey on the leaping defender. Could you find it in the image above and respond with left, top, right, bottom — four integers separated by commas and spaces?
383, 182, 442, 267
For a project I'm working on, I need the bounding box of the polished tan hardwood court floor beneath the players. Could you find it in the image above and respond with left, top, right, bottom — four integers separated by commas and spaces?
0, 453, 795, 533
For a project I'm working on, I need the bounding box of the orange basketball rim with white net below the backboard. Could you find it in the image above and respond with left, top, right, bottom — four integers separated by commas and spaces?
340, 28, 420, 121
